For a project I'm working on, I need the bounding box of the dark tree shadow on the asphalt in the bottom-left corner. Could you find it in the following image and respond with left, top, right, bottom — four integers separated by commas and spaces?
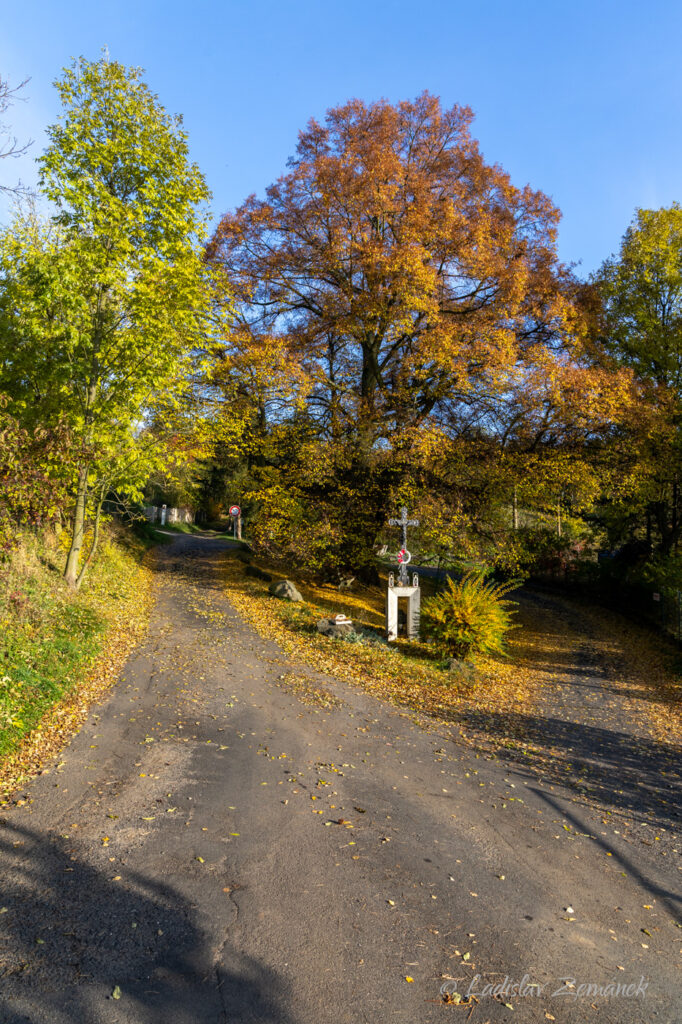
0, 823, 293, 1024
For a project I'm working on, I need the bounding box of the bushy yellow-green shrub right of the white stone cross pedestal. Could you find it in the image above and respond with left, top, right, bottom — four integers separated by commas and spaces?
421, 572, 519, 658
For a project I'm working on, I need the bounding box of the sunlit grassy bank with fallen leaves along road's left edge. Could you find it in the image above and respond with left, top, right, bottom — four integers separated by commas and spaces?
0, 528, 152, 800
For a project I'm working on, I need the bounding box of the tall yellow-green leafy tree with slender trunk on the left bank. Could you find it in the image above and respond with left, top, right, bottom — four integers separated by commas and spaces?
0, 58, 211, 586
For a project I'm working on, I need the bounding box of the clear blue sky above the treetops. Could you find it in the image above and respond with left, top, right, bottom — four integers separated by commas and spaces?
0, 0, 682, 274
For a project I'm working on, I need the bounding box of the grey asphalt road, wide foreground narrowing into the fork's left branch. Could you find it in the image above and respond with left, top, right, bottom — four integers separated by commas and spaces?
0, 537, 682, 1024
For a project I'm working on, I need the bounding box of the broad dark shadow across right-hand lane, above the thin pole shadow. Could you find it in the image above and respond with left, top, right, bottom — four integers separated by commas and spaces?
447, 709, 682, 826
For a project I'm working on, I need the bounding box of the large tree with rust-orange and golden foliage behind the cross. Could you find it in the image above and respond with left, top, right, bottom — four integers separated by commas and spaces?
208, 93, 622, 568
